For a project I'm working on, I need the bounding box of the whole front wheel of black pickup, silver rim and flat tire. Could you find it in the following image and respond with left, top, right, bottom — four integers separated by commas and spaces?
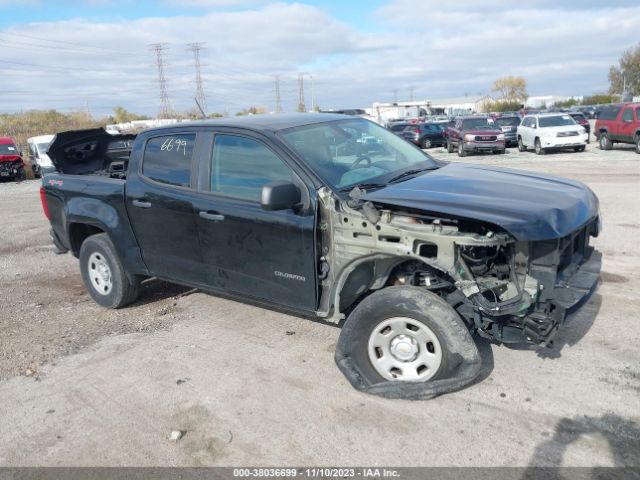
336, 286, 480, 398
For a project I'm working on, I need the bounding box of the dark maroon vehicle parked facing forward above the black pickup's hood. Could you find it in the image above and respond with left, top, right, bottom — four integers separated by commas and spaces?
447, 116, 505, 157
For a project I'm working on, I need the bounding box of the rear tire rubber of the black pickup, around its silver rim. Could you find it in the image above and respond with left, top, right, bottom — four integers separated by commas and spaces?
79, 233, 139, 308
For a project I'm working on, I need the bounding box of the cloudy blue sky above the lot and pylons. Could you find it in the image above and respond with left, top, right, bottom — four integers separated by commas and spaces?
0, 0, 640, 116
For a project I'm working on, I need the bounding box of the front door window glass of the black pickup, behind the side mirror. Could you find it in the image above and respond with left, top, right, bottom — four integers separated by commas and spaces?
211, 135, 293, 202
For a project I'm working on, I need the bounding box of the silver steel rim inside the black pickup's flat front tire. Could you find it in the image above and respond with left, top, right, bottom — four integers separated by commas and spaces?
367, 317, 442, 382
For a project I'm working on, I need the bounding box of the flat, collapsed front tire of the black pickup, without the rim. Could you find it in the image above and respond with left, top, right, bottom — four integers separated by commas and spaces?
336, 286, 480, 398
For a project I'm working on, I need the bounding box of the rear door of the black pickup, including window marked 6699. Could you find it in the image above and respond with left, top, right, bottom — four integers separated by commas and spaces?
126, 130, 205, 284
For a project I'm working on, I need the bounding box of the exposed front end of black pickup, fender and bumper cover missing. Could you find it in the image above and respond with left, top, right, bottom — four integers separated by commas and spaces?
318, 189, 600, 346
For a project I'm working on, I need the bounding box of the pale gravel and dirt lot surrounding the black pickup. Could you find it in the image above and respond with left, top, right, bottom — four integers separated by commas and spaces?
0, 143, 640, 466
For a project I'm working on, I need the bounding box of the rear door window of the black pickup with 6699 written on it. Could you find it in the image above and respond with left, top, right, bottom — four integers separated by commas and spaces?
142, 133, 196, 187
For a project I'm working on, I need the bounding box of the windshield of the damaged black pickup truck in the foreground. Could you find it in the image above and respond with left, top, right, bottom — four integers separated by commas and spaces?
281, 119, 437, 189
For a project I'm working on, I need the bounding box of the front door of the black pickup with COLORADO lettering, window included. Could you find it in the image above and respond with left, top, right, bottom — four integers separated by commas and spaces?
196, 134, 316, 310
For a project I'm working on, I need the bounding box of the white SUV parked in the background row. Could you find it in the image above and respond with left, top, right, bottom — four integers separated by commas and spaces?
518, 113, 587, 155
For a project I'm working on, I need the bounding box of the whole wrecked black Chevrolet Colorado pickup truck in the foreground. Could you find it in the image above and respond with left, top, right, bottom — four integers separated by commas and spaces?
41, 114, 600, 398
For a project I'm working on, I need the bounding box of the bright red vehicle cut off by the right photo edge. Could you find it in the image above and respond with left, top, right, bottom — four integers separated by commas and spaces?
594, 103, 640, 153
